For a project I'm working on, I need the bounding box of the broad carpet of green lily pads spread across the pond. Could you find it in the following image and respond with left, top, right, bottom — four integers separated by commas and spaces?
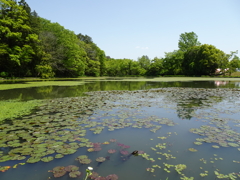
0, 88, 240, 180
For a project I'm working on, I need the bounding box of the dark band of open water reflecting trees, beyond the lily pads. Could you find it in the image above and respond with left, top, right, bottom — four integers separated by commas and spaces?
0, 80, 240, 101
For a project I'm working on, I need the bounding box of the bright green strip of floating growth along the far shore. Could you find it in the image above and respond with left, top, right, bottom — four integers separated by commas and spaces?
0, 77, 240, 90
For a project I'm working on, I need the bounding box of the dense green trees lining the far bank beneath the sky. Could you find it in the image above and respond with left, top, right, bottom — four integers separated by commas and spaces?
0, 0, 240, 78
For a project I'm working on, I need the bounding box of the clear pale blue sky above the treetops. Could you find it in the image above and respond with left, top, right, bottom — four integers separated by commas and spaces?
26, 0, 240, 60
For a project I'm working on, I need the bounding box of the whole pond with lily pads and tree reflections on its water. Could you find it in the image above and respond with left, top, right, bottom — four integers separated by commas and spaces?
0, 79, 240, 180
